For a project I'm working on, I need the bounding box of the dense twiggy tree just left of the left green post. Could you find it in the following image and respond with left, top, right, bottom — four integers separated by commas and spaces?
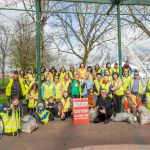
11, 17, 36, 69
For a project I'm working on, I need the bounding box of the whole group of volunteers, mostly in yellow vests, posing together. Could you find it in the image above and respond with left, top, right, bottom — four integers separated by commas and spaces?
1, 61, 150, 133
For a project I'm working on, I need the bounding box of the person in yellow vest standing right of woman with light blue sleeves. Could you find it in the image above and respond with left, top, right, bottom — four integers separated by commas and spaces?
54, 76, 63, 103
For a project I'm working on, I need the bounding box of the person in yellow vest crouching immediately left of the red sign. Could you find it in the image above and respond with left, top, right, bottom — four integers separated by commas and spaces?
61, 91, 72, 120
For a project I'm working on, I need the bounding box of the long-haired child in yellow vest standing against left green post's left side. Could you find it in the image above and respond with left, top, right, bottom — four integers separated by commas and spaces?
28, 83, 38, 116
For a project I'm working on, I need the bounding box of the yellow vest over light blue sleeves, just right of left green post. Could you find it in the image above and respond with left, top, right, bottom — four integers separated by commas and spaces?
42, 82, 54, 99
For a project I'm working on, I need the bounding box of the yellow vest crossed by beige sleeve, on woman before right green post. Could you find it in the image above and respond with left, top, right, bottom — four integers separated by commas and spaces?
113, 79, 124, 96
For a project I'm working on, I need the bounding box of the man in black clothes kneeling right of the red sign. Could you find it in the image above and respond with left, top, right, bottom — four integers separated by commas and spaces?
94, 89, 112, 124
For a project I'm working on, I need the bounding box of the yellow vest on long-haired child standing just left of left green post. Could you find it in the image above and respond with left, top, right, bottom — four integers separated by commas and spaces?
28, 90, 38, 108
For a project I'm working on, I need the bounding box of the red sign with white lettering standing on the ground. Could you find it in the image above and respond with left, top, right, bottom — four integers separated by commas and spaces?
73, 98, 90, 124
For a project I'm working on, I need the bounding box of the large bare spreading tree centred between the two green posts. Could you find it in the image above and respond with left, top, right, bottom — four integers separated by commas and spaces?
53, 4, 114, 64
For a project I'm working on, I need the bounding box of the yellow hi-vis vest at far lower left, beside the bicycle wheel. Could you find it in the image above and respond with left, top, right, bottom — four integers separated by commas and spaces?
0, 108, 21, 133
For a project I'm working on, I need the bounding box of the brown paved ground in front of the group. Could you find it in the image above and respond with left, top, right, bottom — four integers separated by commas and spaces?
0, 120, 150, 150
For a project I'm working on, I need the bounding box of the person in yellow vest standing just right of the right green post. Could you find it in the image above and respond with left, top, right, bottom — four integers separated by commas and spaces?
122, 69, 132, 93
